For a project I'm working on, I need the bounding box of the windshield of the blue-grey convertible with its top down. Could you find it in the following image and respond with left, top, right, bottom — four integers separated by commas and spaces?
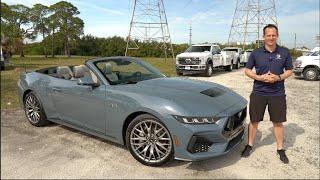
94, 59, 166, 85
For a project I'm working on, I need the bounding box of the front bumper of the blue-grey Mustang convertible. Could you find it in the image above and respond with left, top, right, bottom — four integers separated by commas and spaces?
162, 101, 247, 161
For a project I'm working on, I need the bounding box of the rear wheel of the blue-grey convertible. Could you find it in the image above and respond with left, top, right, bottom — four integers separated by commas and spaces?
24, 92, 49, 127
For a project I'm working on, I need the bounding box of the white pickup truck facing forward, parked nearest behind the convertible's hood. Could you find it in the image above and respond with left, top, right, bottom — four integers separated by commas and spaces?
176, 44, 233, 77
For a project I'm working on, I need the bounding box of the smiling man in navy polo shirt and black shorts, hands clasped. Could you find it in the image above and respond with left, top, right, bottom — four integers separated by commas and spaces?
241, 24, 293, 164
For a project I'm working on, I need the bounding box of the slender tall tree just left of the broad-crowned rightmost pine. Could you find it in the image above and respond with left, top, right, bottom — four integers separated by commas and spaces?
30, 4, 50, 58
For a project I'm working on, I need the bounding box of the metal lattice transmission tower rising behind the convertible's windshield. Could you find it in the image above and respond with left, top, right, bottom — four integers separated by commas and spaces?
125, 0, 174, 59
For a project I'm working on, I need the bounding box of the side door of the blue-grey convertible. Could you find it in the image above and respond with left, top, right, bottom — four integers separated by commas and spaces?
51, 79, 107, 134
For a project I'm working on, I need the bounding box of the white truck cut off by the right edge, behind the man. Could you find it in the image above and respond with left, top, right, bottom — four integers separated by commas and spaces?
293, 48, 320, 81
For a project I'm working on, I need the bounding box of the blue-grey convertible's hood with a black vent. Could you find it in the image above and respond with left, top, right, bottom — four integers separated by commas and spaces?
112, 78, 247, 116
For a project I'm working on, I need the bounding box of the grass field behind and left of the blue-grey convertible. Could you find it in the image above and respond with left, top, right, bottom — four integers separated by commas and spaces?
1, 56, 176, 109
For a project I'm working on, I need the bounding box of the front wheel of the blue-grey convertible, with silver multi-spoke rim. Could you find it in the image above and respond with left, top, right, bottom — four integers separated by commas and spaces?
126, 114, 173, 166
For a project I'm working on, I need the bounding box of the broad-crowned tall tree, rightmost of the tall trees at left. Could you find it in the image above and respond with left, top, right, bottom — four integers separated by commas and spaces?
50, 1, 84, 57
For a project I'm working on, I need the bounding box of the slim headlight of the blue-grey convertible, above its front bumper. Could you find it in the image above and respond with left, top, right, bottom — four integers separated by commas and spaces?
173, 115, 220, 124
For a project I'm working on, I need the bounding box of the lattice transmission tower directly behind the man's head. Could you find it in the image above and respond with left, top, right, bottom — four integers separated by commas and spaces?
228, 0, 278, 47
